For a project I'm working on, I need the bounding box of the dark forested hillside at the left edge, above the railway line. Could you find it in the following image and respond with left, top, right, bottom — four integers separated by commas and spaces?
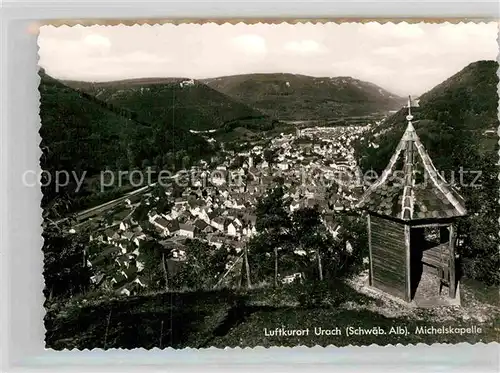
39, 71, 213, 214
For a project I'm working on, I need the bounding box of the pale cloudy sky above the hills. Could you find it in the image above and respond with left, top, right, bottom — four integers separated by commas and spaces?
38, 22, 498, 96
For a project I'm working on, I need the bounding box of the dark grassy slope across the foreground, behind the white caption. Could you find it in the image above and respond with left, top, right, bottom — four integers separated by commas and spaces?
45, 283, 500, 350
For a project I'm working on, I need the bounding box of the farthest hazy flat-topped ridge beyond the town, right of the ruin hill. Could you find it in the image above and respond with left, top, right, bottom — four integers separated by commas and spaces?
201, 73, 404, 120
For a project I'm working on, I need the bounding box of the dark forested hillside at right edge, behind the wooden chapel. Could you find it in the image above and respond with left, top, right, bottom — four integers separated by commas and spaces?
357, 61, 500, 283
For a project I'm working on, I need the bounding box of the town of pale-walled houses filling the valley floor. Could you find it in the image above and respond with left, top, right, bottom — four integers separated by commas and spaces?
83, 123, 372, 294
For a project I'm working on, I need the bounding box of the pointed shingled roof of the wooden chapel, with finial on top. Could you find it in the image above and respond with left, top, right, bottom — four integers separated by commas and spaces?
358, 101, 467, 221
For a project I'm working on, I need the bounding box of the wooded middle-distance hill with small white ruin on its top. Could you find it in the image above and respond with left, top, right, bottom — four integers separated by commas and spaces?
65, 78, 276, 131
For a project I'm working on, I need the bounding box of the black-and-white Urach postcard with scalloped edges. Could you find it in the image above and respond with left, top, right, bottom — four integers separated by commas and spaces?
37, 21, 500, 350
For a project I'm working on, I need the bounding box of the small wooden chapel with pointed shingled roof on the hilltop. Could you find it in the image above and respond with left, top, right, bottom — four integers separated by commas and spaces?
358, 99, 467, 302
